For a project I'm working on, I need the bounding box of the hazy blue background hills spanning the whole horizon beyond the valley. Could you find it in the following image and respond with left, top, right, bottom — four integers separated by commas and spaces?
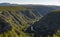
0, 3, 60, 16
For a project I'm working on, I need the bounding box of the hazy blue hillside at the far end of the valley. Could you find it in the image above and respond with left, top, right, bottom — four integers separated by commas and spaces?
24, 5, 60, 16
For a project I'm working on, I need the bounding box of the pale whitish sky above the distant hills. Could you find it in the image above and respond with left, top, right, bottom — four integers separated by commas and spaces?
0, 0, 60, 6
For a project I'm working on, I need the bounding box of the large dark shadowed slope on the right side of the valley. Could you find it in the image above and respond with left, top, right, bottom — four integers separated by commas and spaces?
25, 10, 60, 37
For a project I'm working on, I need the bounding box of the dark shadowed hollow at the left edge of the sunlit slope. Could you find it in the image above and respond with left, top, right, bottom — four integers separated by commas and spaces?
0, 18, 12, 34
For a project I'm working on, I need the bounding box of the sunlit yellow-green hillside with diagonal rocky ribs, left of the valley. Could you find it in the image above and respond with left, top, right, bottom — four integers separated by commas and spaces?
0, 6, 41, 37
